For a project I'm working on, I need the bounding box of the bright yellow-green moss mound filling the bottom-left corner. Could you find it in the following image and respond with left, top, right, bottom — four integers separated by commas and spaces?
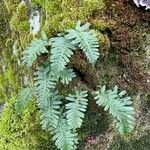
0, 97, 53, 150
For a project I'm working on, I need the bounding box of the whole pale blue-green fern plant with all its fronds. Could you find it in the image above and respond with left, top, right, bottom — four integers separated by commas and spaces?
16, 21, 134, 150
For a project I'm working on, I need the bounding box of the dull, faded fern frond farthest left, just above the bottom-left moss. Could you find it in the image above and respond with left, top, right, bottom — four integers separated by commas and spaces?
15, 87, 33, 114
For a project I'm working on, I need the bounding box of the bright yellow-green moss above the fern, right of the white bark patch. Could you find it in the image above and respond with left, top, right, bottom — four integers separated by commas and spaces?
32, 0, 105, 35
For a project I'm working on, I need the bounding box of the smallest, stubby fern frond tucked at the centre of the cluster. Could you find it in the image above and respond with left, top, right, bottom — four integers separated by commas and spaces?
60, 69, 76, 84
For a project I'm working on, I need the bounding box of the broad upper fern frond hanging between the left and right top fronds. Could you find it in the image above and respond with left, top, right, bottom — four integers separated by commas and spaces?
50, 37, 76, 73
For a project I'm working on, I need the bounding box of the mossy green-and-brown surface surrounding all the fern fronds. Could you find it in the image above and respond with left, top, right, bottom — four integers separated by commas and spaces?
0, 0, 150, 150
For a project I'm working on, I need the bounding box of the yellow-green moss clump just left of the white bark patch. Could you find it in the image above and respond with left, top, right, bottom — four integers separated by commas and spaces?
10, 2, 29, 32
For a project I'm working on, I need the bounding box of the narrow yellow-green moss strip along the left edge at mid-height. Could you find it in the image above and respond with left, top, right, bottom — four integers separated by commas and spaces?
0, 39, 21, 101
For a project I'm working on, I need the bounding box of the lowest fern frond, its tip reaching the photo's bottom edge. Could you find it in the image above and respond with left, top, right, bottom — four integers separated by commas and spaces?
51, 118, 78, 150
